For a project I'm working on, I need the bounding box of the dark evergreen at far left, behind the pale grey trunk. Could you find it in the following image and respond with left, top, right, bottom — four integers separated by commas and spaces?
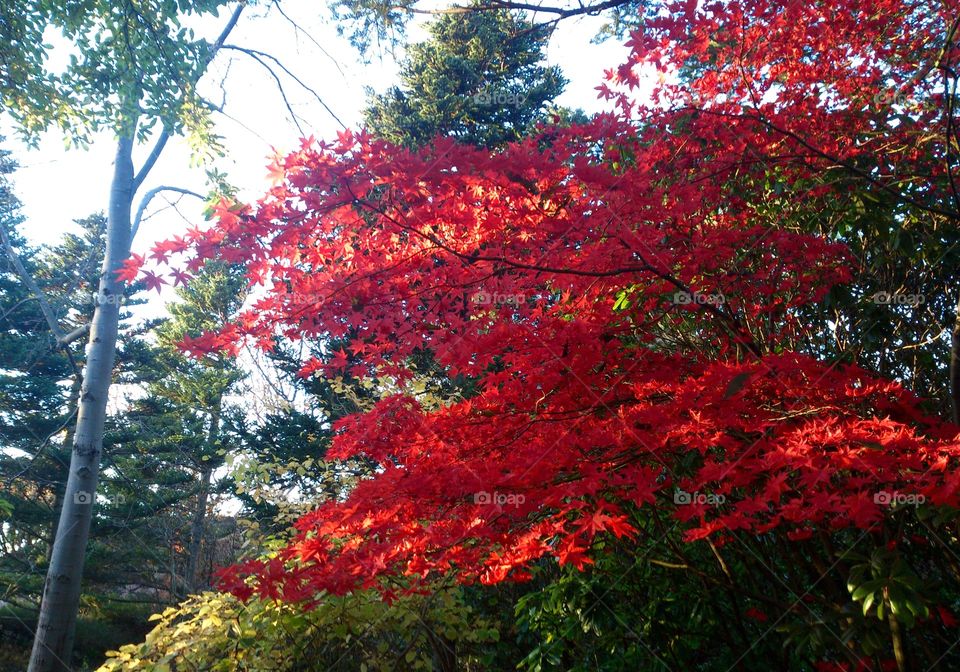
0, 151, 104, 603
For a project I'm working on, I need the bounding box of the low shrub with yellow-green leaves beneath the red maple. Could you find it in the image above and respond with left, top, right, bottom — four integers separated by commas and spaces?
99, 589, 498, 672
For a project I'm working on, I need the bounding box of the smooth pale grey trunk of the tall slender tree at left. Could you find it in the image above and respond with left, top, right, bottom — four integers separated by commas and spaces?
29, 137, 134, 672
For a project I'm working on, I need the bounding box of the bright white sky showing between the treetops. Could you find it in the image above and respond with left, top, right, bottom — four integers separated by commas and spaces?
0, 0, 626, 262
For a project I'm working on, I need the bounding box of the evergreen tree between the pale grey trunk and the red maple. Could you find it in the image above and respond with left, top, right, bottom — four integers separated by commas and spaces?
104, 264, 245, 596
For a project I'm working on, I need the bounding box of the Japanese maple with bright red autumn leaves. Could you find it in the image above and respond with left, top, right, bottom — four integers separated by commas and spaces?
129, 0, 960, 669
